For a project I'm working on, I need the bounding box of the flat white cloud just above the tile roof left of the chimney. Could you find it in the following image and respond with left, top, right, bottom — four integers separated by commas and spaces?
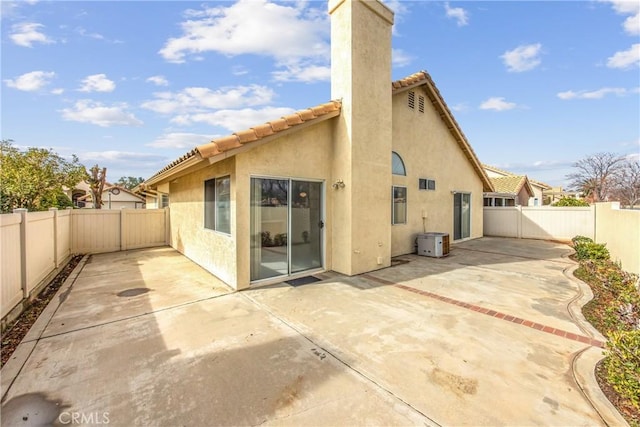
171, 107, 294, 132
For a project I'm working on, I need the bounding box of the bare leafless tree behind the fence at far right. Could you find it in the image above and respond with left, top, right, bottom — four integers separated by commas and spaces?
567, 153, 624, 202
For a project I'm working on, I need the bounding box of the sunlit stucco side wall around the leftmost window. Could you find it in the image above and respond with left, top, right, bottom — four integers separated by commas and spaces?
169, 158, 237, 287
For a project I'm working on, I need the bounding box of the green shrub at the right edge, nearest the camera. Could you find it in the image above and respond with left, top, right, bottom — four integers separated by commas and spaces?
604, 330, 640, 409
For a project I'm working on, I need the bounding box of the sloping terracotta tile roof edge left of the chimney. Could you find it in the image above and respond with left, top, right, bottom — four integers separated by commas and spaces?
146, 101, 342, 186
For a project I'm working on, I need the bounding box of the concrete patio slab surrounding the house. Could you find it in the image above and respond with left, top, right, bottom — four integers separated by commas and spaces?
2, 239, 625, 426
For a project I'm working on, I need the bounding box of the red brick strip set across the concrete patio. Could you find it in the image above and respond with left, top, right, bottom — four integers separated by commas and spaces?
362, 273, 604, 348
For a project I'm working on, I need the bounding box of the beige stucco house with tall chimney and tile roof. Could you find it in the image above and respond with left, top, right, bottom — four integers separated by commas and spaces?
142, 0, 492, 289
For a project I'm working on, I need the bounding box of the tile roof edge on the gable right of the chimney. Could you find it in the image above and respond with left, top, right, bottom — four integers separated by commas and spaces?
391, 70, 493, 191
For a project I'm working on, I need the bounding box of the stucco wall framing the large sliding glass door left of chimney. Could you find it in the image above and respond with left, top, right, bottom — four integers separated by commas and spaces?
235, 119, 339, 289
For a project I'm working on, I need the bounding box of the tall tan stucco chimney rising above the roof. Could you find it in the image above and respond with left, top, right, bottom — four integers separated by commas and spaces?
328, 0, 393, 275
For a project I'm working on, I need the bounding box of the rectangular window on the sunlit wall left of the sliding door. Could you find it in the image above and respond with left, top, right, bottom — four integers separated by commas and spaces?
204, 176, 231, 234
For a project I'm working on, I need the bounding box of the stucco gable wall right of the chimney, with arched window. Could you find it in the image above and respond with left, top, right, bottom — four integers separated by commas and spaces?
389, 88, 483, 256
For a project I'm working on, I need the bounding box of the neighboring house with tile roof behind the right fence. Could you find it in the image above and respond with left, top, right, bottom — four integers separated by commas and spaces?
482, 164, 551, 206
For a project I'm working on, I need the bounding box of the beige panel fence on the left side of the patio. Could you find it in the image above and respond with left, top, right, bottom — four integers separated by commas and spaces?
0, 208, 169, 319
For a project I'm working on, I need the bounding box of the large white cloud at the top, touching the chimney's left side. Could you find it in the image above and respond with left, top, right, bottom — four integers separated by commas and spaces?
158, 0, 330, 82
